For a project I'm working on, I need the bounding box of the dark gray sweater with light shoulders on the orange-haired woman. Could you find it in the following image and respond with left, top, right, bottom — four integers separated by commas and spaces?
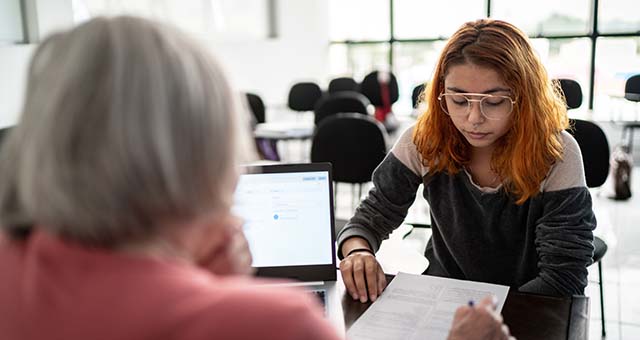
338, 128, 596, 296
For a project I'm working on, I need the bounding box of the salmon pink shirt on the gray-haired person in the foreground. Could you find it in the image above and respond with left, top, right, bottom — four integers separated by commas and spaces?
0, 232, 338, 340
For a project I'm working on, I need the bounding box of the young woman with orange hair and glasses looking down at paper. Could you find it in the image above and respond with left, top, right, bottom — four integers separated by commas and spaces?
338, 19, 596, 302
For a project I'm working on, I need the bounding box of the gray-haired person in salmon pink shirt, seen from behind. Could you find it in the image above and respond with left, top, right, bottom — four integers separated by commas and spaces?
0, 17, 504, 340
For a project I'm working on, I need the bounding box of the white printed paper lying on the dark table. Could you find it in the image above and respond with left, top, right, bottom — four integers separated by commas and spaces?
347, 273, 509, 340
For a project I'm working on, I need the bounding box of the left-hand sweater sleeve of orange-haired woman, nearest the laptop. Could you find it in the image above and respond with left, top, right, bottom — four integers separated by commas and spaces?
338, 125, 422, 259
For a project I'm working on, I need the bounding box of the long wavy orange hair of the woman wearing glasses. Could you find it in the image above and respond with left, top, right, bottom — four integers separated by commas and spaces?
413, 19, 569, 204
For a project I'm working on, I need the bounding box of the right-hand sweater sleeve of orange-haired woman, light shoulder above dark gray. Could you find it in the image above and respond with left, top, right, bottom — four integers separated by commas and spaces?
519, 134, 596, 296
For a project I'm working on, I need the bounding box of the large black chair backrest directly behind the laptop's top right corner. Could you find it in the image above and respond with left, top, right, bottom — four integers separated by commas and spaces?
311, 113, 387, 183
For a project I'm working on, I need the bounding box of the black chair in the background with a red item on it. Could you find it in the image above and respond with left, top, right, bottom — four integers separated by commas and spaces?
360, 71, 399, 132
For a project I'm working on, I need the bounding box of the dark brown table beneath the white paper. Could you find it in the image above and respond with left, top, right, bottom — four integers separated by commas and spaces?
338, 274, 589, 340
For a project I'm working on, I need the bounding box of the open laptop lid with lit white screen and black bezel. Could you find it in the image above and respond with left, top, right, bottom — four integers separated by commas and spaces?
232, 163, 336, 281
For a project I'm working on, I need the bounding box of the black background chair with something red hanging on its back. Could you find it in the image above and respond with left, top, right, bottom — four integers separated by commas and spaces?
360, 71, 399, 132
